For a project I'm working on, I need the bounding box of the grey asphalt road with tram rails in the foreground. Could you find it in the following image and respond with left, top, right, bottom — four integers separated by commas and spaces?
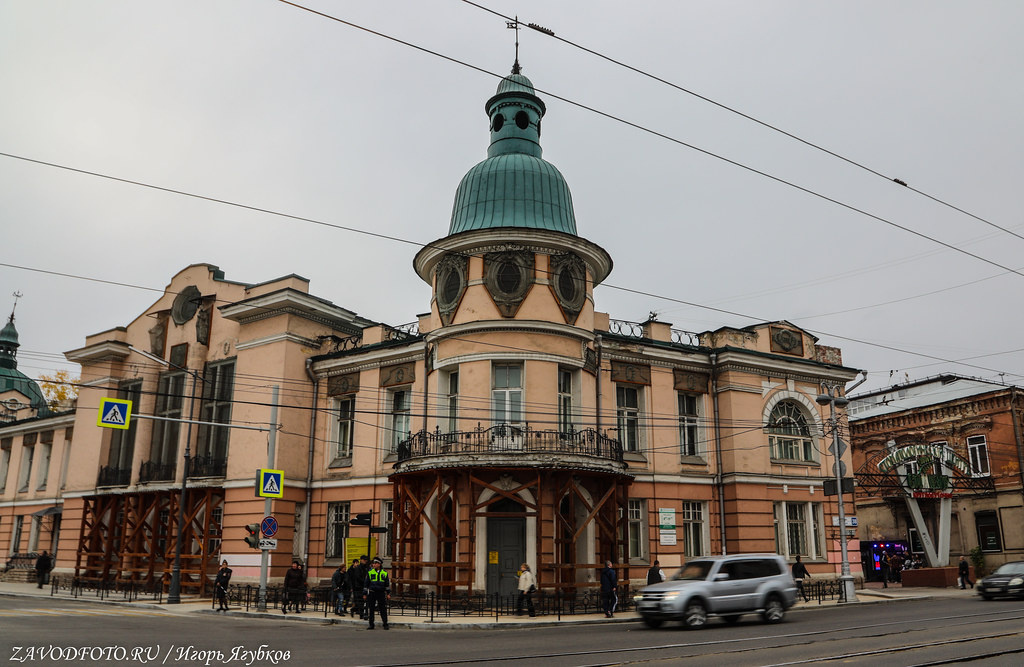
0, 597, 1024, 667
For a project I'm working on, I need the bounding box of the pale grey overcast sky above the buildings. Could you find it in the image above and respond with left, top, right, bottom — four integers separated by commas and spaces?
0, 0, 1024, 397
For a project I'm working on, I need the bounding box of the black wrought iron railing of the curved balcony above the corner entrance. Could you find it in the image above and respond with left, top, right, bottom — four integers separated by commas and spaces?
397, 424, 623, 463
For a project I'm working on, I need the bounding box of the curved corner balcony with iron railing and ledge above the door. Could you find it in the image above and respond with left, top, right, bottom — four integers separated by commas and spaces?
394, 424, 627, 472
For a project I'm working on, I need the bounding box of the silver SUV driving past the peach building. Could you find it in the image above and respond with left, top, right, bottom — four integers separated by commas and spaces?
634, 553, 797, 628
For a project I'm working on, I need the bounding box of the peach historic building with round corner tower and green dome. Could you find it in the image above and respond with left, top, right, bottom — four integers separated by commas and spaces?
0, 67, 858, 592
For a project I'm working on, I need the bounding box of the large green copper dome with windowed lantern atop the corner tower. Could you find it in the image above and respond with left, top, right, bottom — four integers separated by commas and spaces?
449, 68, 577, 236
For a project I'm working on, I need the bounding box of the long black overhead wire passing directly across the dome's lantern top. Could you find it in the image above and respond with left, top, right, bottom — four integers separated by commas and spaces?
266, 0, 1024, 278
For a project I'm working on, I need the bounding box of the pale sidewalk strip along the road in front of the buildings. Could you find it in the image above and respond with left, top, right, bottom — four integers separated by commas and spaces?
0, 582, 977, 630
